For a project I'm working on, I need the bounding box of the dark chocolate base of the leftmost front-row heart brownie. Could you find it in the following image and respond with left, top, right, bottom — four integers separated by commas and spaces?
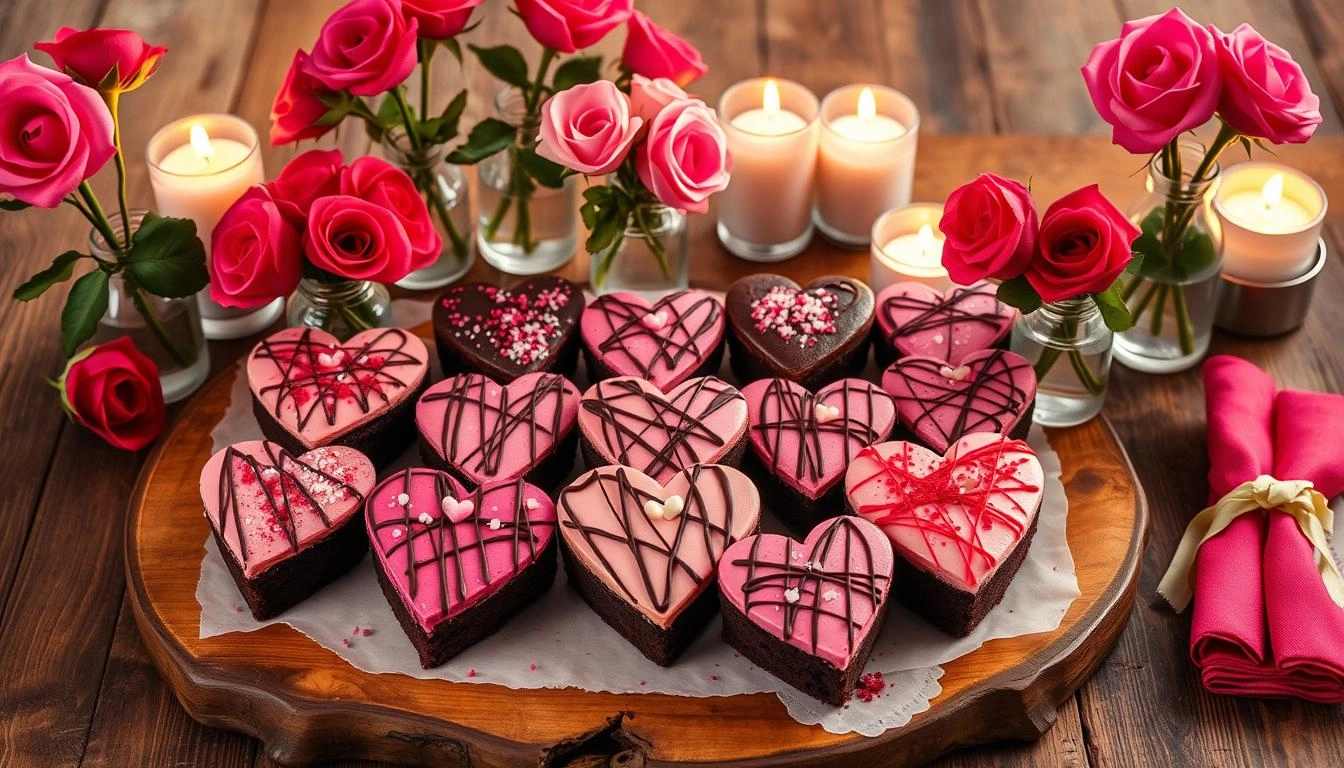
210, 512, 368, 621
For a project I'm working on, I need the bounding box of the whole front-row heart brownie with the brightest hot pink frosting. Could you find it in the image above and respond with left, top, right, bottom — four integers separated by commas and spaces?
364, 468, 555, 668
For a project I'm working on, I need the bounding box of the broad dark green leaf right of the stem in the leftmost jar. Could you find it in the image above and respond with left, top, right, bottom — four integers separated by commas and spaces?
126, 214, 210, 299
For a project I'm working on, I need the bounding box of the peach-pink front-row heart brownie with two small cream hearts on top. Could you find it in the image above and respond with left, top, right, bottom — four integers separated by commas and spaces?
556, 464, 761, 664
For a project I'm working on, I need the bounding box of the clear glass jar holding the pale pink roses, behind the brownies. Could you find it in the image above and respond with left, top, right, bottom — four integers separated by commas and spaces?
589, 203, 688, 299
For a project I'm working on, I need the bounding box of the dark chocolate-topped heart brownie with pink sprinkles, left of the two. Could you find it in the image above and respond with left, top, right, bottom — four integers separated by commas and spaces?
433, 276, 583, 382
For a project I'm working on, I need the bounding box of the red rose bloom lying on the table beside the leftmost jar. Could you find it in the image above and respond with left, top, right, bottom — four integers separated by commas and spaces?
58, 336, 164, 451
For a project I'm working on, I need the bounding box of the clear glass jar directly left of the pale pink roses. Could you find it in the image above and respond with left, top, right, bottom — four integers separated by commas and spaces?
476, 87, 579, 274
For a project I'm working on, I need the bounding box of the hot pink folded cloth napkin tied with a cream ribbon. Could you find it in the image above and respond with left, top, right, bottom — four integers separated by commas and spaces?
1189, 355, 1344, 703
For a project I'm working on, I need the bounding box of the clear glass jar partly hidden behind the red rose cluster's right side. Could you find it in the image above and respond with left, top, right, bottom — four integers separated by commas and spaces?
383, 126, 476, 291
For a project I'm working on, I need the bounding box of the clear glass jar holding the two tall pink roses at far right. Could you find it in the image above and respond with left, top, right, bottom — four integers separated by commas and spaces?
1116, 141, 1223, 374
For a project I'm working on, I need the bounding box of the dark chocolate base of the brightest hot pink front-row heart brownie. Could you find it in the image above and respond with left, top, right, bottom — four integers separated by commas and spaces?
374, 535, 558, 670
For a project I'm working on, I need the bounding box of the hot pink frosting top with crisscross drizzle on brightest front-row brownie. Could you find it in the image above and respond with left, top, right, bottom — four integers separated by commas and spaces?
364, 468, 555, 632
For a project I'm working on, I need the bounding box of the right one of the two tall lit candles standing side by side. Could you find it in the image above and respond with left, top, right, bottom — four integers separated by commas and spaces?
816, 85, 919, 247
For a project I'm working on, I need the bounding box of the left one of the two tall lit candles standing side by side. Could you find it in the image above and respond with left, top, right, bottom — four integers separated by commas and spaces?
718, 78, 817, 261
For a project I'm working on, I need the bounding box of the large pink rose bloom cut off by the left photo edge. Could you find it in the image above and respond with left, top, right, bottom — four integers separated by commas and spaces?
0, 54, 117, 208
